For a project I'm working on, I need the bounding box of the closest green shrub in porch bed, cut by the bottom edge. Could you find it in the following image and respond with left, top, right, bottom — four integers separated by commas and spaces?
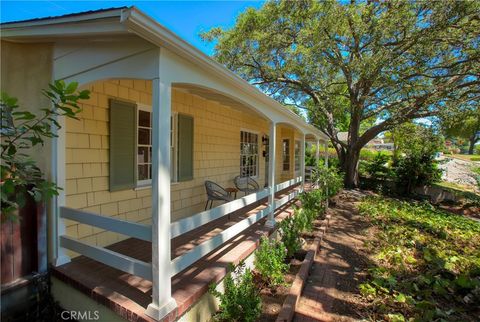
210, 262, 262, 322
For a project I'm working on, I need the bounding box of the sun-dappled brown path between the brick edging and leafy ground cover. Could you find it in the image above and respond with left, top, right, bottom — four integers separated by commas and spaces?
294, 191, 367, 321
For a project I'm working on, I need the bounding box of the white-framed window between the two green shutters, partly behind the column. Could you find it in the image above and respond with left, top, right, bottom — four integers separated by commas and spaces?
136, 104, 178, 186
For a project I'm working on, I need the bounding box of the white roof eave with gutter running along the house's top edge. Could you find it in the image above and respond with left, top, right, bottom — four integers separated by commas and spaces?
0, 7, 328, 141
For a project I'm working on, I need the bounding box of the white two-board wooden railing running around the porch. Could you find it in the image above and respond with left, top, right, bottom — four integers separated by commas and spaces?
60, 177, 302, 280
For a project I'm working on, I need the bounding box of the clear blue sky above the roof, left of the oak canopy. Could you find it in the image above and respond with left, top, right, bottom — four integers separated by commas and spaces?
0, 0, 262, 55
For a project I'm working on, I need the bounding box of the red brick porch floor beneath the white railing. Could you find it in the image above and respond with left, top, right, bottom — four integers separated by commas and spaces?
52, 186, 308, 321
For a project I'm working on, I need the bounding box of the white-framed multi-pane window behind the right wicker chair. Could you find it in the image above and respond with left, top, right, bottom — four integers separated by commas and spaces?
240, 131, 258, 177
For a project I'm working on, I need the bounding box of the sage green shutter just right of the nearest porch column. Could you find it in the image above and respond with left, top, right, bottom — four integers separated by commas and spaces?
177, 114, 193, 181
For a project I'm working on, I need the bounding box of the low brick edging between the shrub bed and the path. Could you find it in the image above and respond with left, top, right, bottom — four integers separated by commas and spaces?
276, 214, 331, 322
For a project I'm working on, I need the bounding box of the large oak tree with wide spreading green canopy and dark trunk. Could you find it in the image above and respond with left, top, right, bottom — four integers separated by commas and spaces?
203, 0, 480, 187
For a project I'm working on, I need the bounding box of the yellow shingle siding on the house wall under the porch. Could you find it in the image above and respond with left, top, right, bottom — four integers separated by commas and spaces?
65, 80, 286, 254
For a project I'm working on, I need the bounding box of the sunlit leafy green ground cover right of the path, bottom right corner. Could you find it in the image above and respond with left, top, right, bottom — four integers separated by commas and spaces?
360, 197, 480, 321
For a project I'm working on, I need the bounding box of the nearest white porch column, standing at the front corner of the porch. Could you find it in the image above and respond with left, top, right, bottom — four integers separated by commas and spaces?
146, 78, 177, 320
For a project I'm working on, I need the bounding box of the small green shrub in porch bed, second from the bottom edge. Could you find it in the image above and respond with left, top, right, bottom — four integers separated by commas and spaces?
255, 236, 289, 286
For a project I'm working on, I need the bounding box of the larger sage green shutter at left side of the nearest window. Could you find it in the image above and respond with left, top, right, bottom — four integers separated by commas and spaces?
110, 99, 137, 191
